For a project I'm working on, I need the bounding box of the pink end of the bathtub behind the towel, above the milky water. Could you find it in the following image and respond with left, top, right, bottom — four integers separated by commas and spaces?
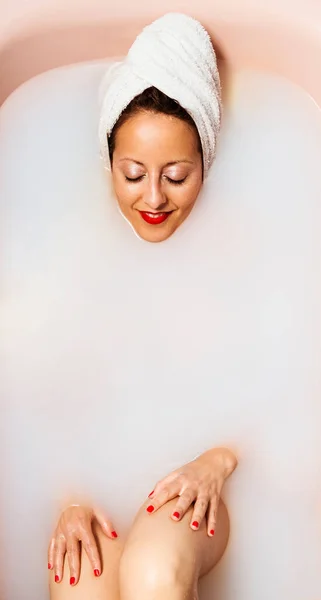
0, 0, 321, 105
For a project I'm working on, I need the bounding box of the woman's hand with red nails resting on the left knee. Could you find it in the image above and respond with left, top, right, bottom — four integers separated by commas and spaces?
48, 506, 118, 585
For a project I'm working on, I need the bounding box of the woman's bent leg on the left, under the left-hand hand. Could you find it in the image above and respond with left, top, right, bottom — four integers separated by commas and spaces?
49, 523, 123, 600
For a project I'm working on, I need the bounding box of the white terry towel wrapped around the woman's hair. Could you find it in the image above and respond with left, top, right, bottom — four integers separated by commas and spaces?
99, 13, 222, 176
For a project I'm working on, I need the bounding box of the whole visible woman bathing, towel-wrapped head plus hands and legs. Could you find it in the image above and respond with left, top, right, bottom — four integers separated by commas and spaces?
48, 14, 237, 600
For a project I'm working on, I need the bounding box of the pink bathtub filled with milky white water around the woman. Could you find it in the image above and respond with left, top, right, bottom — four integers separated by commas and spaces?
0, 0, 321, 600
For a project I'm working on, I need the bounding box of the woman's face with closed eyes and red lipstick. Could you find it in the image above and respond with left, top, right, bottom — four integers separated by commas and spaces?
112, 112, 203, 242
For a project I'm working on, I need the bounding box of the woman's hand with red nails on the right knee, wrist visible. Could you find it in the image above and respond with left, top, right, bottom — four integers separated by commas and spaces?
146, 448, 237, 536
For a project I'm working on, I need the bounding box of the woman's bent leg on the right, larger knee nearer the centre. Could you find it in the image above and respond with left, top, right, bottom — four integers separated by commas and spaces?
119, 500, 229, 600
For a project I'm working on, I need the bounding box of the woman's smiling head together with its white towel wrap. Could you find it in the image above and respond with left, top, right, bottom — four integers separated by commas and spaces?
100, 14, 221, 242
